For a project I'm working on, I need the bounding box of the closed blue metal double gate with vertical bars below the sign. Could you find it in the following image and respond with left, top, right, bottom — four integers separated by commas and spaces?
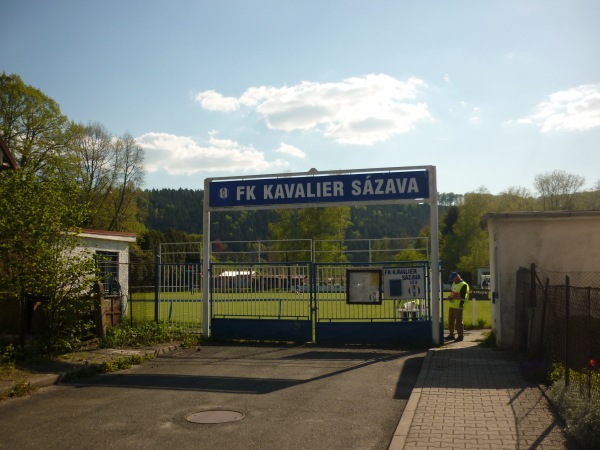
210, 261, 432, 345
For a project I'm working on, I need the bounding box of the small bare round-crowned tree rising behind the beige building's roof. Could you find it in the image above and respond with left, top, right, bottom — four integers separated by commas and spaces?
534, 170, 585, 211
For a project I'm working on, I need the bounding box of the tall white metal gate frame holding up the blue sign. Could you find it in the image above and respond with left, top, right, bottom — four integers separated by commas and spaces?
202, 166, 443, 345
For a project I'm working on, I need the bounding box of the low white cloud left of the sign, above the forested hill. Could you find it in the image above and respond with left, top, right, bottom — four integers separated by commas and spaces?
136, 132, 287, 175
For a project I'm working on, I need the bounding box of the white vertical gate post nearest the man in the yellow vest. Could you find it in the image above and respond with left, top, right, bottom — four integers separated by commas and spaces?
429, 166, 442, 345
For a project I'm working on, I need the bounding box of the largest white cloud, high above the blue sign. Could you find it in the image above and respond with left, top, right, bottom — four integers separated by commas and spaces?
196, 74, 431, 145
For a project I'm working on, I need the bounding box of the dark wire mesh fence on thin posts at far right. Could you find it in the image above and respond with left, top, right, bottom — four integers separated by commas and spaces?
526, 265, 600, 407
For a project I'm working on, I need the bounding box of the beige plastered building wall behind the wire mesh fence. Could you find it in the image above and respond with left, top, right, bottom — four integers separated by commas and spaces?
481, 211, 600, 349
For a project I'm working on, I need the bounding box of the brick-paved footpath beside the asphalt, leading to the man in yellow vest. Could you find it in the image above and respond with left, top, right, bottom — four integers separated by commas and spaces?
389, 331, 579, 450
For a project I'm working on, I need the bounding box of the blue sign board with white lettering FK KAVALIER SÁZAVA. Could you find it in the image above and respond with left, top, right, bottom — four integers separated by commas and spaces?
209, 170, 429, 208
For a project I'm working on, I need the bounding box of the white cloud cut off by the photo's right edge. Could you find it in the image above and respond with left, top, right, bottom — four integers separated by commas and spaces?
516, 84, 600, 133
